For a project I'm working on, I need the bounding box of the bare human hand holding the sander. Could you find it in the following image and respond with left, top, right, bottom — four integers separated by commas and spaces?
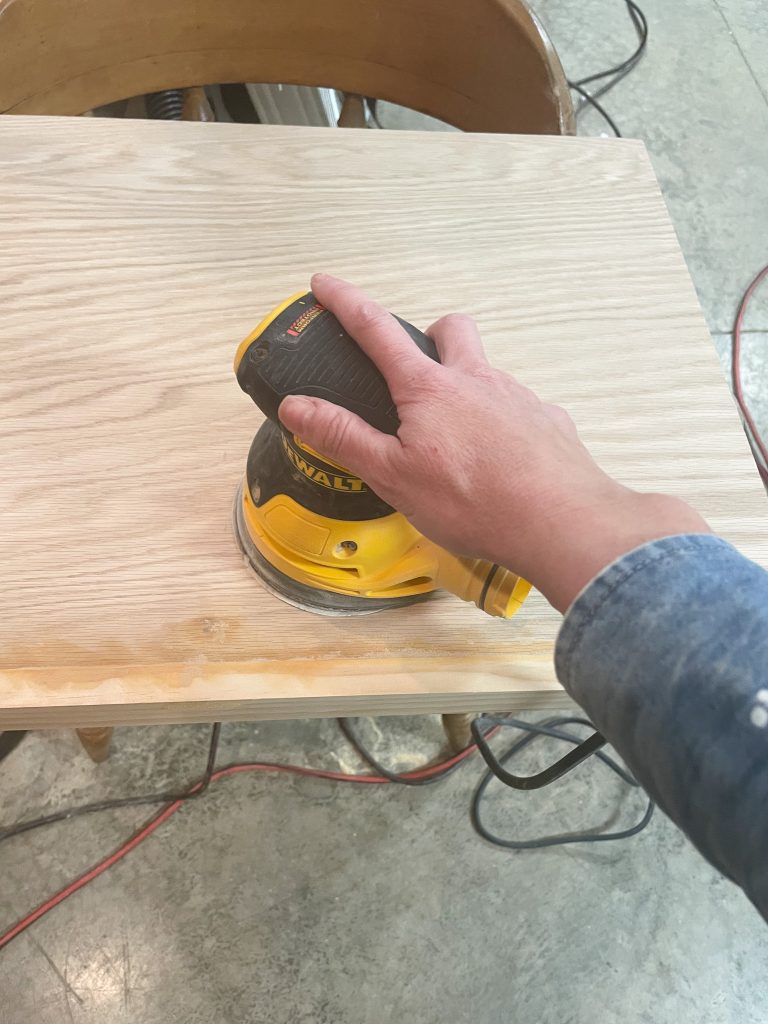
280, 274, 708, 611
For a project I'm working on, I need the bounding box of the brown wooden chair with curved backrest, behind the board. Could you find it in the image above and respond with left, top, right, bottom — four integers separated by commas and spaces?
0, 0, 574, 760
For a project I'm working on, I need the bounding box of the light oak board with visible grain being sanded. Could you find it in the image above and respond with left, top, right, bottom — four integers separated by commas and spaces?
0, 117, 768, 728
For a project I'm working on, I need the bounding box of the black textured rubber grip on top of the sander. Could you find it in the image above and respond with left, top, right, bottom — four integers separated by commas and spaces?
238, 292, 439, 434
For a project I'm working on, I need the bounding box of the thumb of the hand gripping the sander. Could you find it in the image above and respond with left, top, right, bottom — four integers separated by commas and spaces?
278, 394, 399, 483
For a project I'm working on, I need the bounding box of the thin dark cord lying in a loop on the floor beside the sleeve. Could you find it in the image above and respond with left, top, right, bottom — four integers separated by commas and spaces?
469, 715, 655, 850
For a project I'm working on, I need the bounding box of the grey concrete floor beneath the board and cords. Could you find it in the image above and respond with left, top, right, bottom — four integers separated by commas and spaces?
0, 0, 768, 1024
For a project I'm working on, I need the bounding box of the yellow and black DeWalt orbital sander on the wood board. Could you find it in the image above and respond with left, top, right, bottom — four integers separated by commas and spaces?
234, 292, 529, 616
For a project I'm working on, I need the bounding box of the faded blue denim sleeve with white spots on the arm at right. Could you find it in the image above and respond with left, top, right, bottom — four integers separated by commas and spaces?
555, 535, 768, 920
